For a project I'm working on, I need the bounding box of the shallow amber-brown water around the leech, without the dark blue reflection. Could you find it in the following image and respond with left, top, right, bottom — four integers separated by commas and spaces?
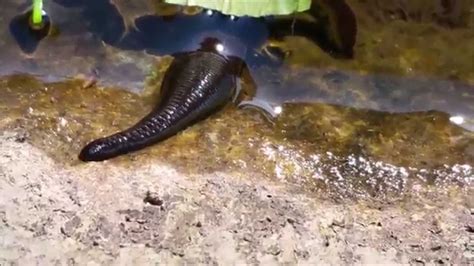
0, 1, 474, 198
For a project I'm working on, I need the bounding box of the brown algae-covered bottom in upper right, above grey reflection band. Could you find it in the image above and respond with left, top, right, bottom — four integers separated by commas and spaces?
283, 0, 474, 84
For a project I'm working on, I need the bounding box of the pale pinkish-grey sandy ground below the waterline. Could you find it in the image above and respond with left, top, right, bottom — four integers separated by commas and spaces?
0, 132, 474, 265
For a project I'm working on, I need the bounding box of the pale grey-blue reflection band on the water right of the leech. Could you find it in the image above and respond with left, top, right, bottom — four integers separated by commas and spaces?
250, 67, 474, 131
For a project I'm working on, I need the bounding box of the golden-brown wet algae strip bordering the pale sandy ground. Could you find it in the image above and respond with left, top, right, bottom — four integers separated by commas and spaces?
0, 71, 474, 198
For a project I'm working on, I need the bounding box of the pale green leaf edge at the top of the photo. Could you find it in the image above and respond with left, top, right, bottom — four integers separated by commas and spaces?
165, 0, 311, 17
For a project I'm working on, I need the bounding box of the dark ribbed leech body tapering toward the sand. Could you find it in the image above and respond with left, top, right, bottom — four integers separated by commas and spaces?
79, 51, 241, 161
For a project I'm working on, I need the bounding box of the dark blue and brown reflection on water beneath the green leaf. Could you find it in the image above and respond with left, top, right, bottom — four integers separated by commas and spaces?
3, 0, 356, 70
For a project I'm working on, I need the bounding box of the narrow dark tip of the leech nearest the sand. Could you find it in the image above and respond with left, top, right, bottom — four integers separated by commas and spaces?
79, 139, 118, 162
